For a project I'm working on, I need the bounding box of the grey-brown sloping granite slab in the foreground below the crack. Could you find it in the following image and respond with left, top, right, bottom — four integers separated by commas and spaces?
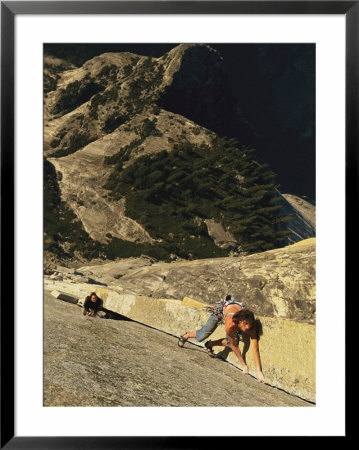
44, 290, 312, 407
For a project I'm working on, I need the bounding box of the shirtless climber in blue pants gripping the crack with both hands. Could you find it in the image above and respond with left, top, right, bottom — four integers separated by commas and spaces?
178, 295, 264, 383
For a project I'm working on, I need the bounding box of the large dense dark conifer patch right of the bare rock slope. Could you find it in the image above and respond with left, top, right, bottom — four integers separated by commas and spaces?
104, 139, 289, 258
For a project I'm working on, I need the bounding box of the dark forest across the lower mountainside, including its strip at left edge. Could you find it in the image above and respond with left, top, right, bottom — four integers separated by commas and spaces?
44, 139, 289, 261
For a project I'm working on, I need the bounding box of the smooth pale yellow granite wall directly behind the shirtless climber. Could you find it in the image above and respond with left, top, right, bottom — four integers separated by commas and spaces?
45, 282, 316, 402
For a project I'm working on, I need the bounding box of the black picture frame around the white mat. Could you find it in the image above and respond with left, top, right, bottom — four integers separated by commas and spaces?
0, 0, 359, 449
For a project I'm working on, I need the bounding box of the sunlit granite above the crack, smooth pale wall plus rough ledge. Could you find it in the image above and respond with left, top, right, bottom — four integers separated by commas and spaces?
44, 239, 316, 401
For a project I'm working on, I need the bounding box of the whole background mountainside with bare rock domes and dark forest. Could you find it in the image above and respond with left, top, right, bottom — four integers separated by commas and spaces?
44, 44, 315, 260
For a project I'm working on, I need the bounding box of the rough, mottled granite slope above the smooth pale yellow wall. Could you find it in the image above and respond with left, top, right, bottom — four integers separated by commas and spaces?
86, 238, 316, 323
